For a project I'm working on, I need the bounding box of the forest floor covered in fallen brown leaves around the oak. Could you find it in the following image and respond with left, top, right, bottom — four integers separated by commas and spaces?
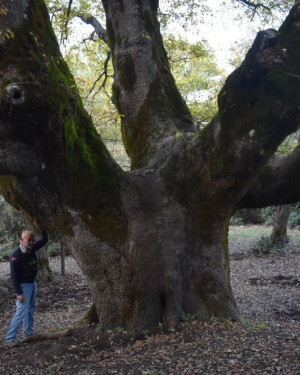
0, 226, 300, 375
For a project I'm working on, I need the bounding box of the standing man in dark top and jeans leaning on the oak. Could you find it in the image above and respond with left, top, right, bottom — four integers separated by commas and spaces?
5, 226, 48, 346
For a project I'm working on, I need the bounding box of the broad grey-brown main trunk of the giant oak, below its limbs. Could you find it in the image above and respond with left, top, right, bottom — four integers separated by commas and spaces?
59, 174, 239, 331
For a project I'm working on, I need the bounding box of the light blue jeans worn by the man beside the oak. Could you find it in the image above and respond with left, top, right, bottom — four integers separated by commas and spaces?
5, 282, 37, 341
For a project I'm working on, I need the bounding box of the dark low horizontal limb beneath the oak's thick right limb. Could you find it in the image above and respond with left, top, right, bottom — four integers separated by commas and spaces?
238, 146, 300, 208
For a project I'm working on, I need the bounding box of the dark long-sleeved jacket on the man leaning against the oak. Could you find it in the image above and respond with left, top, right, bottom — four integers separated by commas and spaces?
9, 230, 48, 295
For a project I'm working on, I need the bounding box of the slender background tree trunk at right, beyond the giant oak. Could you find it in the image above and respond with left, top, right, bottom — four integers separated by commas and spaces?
271, 204, 291, 248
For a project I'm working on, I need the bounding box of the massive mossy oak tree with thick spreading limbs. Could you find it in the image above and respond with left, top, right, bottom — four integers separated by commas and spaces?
0, 0, 300, 330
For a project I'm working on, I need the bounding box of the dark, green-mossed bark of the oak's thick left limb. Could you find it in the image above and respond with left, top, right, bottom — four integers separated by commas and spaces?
0, 0, 126, 243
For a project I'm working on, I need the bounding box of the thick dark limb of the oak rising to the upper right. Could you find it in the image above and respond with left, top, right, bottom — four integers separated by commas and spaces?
162, 2, 300, 210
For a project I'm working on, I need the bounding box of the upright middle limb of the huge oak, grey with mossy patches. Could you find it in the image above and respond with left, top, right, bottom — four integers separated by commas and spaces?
103, 0, 194, 168
